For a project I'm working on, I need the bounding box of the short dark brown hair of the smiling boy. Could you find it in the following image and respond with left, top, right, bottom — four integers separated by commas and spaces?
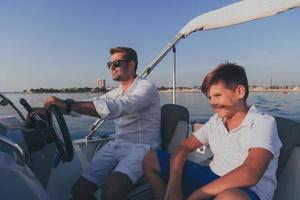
201, 62, 249, 100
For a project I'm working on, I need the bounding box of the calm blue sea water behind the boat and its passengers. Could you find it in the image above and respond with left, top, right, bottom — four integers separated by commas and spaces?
0, 92, 300, 139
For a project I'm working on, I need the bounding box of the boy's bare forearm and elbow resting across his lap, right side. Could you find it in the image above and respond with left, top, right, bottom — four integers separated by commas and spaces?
188, 148, 273, 200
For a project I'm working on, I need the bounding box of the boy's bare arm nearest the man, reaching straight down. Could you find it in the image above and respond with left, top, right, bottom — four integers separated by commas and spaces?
165, 135, 202, 199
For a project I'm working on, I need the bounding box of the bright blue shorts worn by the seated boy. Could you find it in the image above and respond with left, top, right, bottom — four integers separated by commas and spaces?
156, 150, 260, 200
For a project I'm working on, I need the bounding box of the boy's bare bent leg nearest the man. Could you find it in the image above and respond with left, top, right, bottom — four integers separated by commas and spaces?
143, 150, 167, 200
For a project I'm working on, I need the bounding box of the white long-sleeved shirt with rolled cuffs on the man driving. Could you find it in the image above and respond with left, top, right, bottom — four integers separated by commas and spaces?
93, 77, 161, 148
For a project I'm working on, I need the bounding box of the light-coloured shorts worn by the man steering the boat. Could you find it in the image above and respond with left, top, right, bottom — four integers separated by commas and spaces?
82, 140, 150, 188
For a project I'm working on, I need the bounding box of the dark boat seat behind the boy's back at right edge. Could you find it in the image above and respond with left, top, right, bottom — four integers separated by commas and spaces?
274, 117, 300, 200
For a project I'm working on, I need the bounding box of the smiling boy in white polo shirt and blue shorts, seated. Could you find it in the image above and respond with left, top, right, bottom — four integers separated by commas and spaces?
143, 63, 282, 200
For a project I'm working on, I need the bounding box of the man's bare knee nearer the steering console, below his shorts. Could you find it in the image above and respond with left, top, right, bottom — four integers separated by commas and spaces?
71, 176, 98, 200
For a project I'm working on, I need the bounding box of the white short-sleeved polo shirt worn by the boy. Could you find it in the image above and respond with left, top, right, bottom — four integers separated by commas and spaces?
194, 106, 282, 200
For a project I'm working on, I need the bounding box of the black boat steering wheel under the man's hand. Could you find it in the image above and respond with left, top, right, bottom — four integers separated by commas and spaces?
48, 105, 73, 162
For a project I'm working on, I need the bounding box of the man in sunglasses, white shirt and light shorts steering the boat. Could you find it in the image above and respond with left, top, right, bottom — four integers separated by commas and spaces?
44, 47, 160, 200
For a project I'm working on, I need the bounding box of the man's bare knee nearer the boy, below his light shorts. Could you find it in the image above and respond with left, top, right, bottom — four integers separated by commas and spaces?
101, 172, 133, 200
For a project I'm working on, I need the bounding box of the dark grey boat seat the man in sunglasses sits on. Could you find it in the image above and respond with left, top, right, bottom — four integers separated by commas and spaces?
127, 104, 189, 200
